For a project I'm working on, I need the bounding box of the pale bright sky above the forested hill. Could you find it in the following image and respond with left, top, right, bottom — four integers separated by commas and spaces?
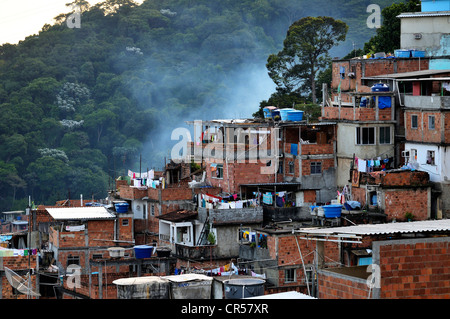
0, 0, 143, 45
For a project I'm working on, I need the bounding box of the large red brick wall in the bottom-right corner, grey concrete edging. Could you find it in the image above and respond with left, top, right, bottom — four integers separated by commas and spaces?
379, 237, 450, 299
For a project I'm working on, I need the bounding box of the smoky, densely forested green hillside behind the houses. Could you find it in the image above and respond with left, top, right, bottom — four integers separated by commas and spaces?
0, 0, 400, 210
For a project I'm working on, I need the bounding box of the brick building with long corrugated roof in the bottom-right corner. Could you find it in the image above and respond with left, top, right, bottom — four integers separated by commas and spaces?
296, 219, 450, 299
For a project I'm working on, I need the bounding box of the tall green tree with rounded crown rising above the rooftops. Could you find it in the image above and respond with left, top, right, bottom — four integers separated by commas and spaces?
266, 17, 348, 103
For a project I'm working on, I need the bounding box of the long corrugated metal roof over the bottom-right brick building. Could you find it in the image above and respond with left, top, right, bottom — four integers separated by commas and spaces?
296, 219, 450, 237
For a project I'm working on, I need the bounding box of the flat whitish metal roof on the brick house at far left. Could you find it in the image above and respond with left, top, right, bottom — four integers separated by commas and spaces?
46, 206, 115, 220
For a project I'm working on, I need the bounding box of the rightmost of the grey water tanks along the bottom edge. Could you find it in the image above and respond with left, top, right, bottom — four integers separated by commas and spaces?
224, 278, 266, 299
